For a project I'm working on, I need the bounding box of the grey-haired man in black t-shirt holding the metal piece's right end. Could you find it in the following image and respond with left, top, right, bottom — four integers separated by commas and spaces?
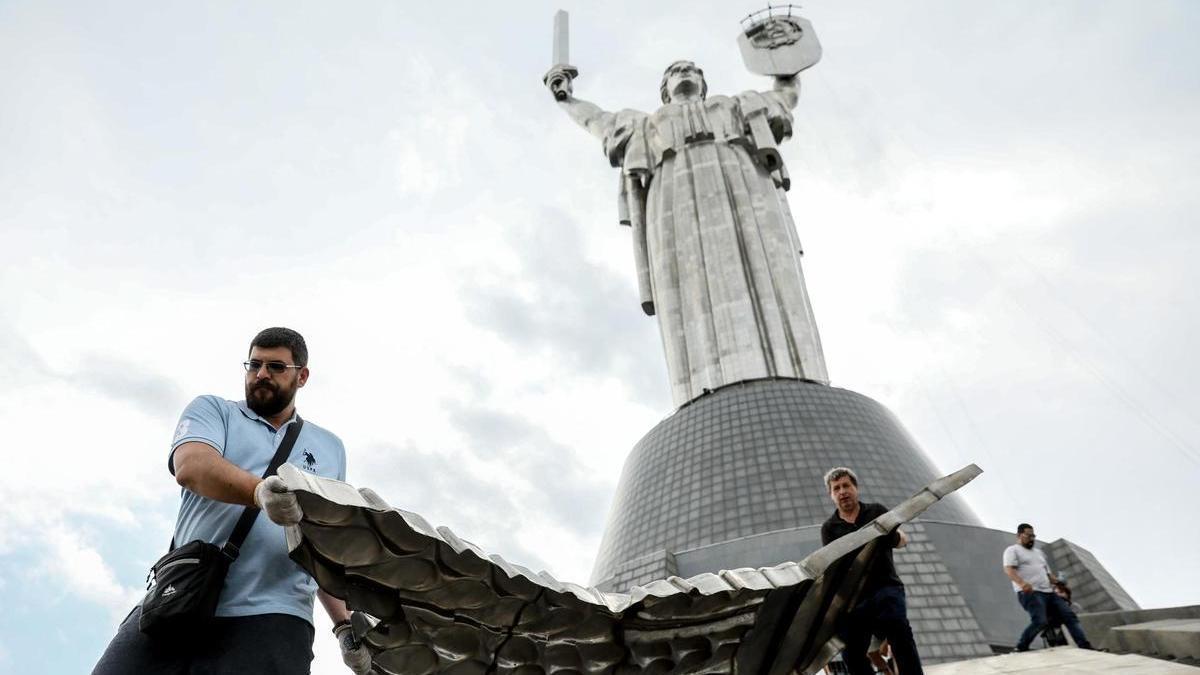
821, 466, 924, 675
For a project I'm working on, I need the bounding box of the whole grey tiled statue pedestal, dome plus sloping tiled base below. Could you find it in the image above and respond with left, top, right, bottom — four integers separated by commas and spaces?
592, 380, 1135, 663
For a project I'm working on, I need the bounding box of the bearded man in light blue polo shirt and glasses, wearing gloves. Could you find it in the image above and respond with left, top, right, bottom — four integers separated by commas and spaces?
94, 328, 371, 675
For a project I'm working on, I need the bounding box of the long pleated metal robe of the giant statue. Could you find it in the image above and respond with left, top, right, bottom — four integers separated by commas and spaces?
604, 91, 828, 406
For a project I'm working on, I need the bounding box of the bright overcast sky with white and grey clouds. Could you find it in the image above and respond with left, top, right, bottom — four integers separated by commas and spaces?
0, 0, 1200, 674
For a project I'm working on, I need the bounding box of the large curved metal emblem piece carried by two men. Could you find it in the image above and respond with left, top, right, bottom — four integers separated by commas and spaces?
278, 464, 980, 675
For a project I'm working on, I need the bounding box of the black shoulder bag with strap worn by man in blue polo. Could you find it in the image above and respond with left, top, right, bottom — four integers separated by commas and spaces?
139, 417, 304, 638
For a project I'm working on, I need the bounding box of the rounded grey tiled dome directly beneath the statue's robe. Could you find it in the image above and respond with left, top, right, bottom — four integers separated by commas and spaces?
592, 380, 982, 584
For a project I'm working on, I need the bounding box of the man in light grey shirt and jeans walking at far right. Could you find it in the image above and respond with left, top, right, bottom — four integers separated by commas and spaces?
1003, 522, 1094, 651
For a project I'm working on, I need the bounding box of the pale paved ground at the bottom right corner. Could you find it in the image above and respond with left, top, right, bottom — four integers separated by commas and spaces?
925, 647, 1200, 675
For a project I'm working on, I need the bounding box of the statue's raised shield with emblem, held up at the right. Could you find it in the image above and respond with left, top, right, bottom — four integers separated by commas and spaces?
738, 14, 821, 77
